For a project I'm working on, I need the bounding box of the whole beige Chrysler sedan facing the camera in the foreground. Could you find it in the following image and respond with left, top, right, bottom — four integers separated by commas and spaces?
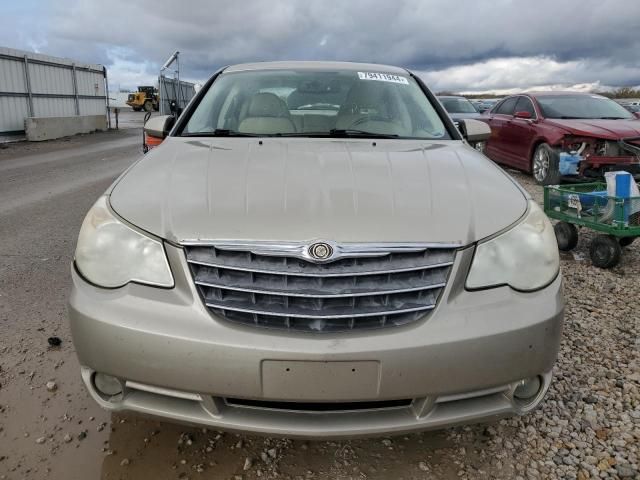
69, 62, 564, 438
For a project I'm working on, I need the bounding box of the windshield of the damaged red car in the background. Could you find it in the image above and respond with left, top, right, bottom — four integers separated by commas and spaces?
536, 95, 633, 119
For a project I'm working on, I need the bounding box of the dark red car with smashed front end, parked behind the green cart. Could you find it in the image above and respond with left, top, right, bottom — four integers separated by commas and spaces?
482, 92, 640, 185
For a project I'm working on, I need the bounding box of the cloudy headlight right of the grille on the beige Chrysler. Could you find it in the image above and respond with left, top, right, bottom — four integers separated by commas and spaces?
467, 200, 560, 291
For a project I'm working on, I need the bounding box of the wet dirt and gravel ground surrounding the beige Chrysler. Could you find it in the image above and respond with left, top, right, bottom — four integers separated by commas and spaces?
0, 118, 640, 480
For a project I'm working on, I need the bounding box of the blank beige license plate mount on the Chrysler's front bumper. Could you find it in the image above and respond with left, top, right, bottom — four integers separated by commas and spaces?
262, 360, 380, 402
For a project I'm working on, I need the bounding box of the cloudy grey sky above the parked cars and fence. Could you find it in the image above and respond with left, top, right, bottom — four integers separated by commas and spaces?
0, 0, 640, 91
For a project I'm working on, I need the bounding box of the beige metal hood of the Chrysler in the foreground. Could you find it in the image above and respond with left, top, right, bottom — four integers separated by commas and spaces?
110, 137, 526, 244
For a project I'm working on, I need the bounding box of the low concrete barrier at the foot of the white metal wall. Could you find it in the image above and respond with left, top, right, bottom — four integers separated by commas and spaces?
24, 115, 107, 142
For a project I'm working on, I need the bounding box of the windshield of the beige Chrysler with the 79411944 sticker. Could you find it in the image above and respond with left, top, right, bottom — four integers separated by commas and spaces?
182, 70, 450, 139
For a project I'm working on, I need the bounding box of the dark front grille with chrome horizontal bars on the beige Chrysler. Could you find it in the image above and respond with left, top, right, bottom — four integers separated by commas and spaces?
185, 244, 455, 332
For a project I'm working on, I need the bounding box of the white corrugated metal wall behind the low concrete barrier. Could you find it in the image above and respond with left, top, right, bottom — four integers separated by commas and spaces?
0, 47, 106, 132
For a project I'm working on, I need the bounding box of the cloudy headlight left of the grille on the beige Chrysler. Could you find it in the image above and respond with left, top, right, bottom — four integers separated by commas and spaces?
75, 196, 173, 288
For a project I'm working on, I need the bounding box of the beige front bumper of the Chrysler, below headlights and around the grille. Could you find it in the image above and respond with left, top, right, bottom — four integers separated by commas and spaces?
69, 246, 564, 438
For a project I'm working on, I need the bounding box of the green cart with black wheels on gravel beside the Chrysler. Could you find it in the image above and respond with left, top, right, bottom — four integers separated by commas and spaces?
544, 182, 640, 268
